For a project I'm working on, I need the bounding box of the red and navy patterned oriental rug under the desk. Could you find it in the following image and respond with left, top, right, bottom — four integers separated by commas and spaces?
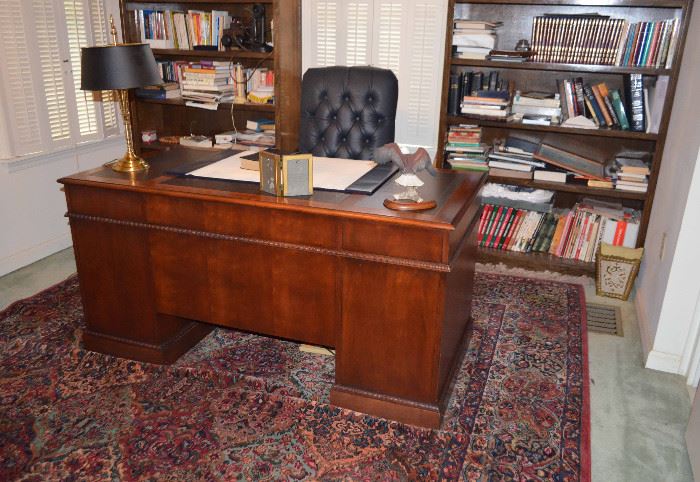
0, 273, 590, 481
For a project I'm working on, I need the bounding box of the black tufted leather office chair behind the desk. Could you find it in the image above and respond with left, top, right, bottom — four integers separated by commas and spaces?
299, 67, 399, 159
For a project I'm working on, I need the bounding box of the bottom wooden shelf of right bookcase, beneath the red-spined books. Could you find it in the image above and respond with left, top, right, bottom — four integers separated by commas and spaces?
477, 248, 595, 276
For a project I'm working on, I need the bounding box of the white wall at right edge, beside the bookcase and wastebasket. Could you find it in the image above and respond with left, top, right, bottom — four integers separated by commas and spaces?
635, 1, 700, 375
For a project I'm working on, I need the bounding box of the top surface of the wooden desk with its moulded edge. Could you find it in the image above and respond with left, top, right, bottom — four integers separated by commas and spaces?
59, 147, 486, 228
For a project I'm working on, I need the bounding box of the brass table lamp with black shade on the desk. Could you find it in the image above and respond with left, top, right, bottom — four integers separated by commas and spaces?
80, 18, 163, 172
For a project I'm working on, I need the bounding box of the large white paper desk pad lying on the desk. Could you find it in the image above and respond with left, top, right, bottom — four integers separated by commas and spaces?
187, 150, 377, 191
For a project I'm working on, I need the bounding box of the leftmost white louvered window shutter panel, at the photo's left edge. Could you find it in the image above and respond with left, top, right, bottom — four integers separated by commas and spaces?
0, 0, 42, 156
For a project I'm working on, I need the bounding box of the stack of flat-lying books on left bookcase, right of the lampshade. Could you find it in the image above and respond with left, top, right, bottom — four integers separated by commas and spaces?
180, 60, 234, 110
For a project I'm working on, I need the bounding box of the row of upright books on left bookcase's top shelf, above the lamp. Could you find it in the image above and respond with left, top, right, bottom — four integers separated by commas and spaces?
131, 10, 237, 50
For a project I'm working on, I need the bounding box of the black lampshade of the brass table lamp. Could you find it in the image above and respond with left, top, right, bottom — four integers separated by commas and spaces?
80, 44, 163, 90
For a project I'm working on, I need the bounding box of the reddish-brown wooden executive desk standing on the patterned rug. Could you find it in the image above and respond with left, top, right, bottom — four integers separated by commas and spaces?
59, 148, 484, 427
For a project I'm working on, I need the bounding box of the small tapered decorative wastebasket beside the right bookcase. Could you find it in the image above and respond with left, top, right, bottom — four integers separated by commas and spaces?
595, 243, 644, 300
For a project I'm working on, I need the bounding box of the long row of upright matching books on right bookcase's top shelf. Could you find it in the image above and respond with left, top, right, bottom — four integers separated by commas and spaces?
531, 14, 680, 68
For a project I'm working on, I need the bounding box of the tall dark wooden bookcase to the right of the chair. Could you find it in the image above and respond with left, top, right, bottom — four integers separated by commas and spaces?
436, 0, 692, 274
